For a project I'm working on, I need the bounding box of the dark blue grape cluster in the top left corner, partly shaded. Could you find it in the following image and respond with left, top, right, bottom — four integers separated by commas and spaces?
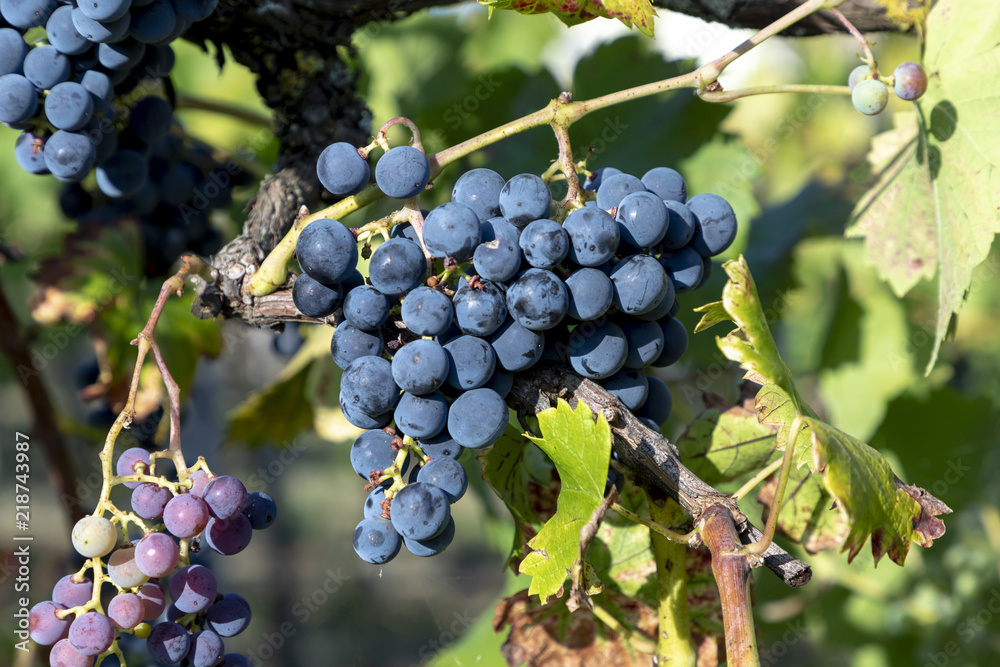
0, 0, 232, 275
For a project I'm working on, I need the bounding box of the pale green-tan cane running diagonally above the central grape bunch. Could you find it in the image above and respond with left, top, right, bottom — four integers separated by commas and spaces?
248, 0, 842, 296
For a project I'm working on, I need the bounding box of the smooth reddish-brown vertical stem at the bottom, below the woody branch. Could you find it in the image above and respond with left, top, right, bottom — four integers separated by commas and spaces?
701, 505, 760, 667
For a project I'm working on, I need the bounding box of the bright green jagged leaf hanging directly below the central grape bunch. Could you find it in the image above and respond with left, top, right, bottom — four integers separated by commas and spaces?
520, 399, 611, 604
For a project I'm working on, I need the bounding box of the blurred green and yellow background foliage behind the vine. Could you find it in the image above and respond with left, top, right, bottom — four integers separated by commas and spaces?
0, 5, 1000, 667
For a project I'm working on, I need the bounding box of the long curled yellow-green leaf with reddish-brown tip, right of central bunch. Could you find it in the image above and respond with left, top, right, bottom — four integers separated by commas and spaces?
696, 256, 950, 565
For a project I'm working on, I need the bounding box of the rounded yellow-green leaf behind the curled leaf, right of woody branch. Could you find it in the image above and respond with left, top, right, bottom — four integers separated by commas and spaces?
675, 399, 776, 486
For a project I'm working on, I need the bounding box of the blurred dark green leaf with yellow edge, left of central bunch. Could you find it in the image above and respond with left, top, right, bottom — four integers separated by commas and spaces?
226, 335, 329, 447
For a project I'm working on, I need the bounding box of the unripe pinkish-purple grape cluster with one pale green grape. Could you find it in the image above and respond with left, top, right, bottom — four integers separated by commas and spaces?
28, 447, 276, 667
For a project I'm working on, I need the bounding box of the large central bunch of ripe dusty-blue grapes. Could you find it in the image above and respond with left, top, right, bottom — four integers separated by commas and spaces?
292, 143, 737, 564
